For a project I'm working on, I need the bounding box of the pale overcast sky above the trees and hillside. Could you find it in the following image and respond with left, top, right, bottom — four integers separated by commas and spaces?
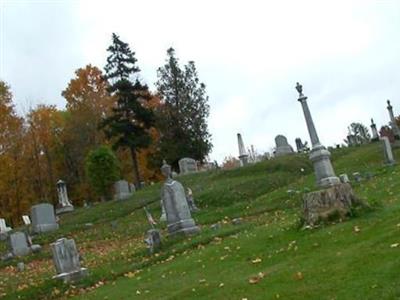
0, 0, 400, 161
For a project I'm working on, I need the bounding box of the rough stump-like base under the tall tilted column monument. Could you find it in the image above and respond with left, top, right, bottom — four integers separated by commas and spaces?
303, 183, 360, 226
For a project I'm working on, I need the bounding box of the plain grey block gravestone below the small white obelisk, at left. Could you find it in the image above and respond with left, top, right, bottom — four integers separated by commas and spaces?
31, 203, 58, 233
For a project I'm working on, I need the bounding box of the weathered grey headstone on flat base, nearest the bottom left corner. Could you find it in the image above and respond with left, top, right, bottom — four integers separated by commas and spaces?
50, 238, 88, 282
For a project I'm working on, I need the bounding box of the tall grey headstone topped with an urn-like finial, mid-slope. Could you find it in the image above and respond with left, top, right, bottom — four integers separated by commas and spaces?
161, 161, 200, 235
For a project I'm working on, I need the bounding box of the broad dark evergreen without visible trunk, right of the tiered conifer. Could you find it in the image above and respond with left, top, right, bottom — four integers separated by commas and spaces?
156, 48, 212, 167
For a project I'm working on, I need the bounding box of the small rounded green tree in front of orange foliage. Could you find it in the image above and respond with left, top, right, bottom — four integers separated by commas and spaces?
85, 146, 120, 200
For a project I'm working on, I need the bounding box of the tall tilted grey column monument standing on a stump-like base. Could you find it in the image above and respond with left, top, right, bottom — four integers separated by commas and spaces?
296, 83, 340, 188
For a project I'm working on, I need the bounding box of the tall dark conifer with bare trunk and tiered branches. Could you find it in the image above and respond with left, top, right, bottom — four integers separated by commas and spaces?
103, 33, 154, 188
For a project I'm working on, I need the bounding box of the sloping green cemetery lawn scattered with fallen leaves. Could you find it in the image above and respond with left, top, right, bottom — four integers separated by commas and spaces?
0, 144, 400, 300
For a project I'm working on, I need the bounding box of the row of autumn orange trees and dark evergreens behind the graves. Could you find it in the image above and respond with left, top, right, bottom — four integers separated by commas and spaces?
0, 34, 212, 224
